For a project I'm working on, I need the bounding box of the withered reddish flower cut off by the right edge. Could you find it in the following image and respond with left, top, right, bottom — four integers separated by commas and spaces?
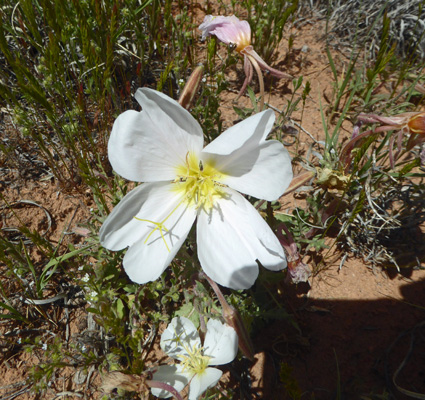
341, 112, 425, 168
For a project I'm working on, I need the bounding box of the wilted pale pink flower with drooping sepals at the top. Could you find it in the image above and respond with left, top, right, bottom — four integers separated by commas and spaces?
199, 15, 292, 110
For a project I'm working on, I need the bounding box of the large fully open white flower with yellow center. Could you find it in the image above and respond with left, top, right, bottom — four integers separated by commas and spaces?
99, 88, 292, 289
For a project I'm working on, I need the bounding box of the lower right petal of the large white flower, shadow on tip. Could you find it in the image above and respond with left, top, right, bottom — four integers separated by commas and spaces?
197, 188, 286, 289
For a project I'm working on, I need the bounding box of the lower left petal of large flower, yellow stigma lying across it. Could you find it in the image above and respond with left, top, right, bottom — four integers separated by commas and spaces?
100, 182, 196, 283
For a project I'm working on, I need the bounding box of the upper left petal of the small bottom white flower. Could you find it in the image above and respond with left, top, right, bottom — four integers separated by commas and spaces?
160, 317, 201, 360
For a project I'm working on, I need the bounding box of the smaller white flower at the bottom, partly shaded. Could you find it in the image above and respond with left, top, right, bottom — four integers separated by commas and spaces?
151, 317, 238, 400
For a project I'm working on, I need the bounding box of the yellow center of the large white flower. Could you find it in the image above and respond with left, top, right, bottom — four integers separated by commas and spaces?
175, 152, 225, 212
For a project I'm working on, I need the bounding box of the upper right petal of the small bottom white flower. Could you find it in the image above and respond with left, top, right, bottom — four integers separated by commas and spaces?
204, 319, 238, 365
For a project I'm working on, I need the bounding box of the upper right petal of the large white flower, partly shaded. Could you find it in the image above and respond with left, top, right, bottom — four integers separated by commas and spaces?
201, 110, 293, 201
